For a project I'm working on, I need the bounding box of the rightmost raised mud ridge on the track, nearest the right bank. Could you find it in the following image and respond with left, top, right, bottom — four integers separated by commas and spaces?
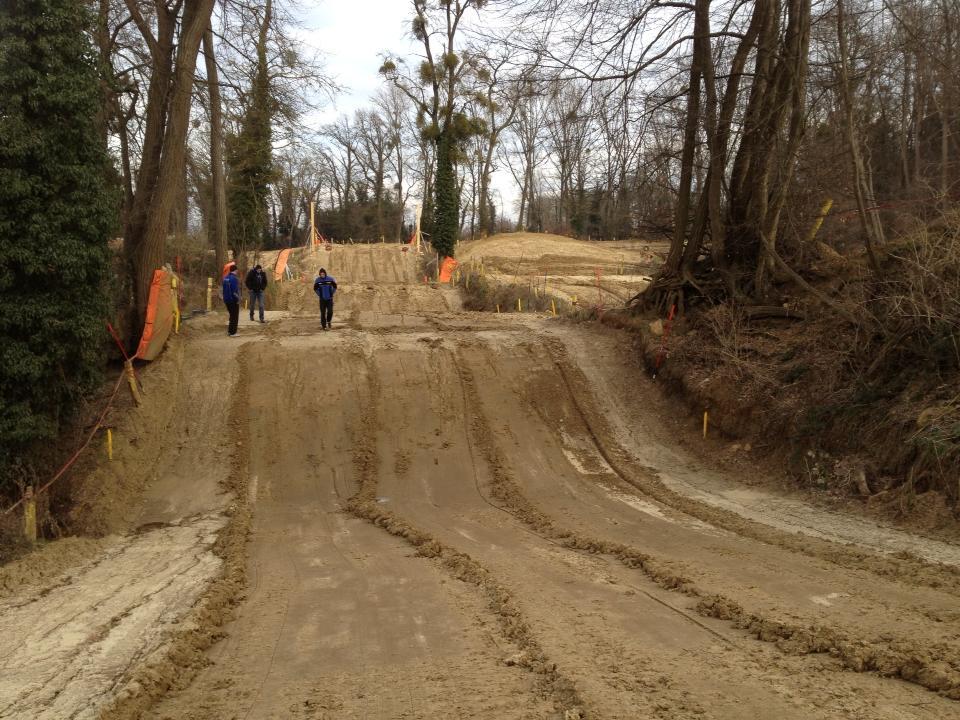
547, 340, 960, 596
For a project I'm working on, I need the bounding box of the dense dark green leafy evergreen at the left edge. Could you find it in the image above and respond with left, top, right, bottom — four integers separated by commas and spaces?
0, 0, 118, 482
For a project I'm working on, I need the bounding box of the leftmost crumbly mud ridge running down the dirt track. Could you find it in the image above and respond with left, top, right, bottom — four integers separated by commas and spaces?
98, 348, 252, 720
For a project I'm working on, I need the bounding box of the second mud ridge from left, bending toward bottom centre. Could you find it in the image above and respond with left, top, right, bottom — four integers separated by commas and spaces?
345, 340, 588, 720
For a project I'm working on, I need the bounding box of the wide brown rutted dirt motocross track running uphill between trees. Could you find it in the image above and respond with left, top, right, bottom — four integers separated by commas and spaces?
0, 245, 960, 720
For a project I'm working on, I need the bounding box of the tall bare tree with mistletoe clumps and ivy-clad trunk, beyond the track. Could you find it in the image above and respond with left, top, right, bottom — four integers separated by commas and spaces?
380, 0, 486, 257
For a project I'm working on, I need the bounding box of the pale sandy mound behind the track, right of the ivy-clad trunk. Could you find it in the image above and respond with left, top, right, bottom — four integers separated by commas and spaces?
457, 232, 668, 306
